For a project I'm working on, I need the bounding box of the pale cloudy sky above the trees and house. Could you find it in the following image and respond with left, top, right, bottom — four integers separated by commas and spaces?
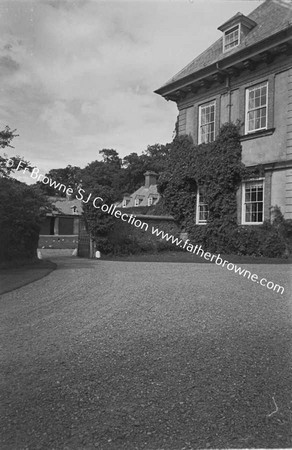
0, 0, 261, 173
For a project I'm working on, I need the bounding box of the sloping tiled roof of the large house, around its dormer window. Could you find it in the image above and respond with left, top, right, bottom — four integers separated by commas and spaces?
156, 0, 292, 93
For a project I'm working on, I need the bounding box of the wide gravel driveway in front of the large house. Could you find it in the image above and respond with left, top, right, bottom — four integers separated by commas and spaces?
0, 258, 292, 450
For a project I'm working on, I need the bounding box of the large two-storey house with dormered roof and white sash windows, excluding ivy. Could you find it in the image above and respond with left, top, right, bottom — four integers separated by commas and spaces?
155, 0, 292, 225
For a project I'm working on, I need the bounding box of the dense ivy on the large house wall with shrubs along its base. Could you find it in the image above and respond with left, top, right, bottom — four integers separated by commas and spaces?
158, 123, 289, 256
